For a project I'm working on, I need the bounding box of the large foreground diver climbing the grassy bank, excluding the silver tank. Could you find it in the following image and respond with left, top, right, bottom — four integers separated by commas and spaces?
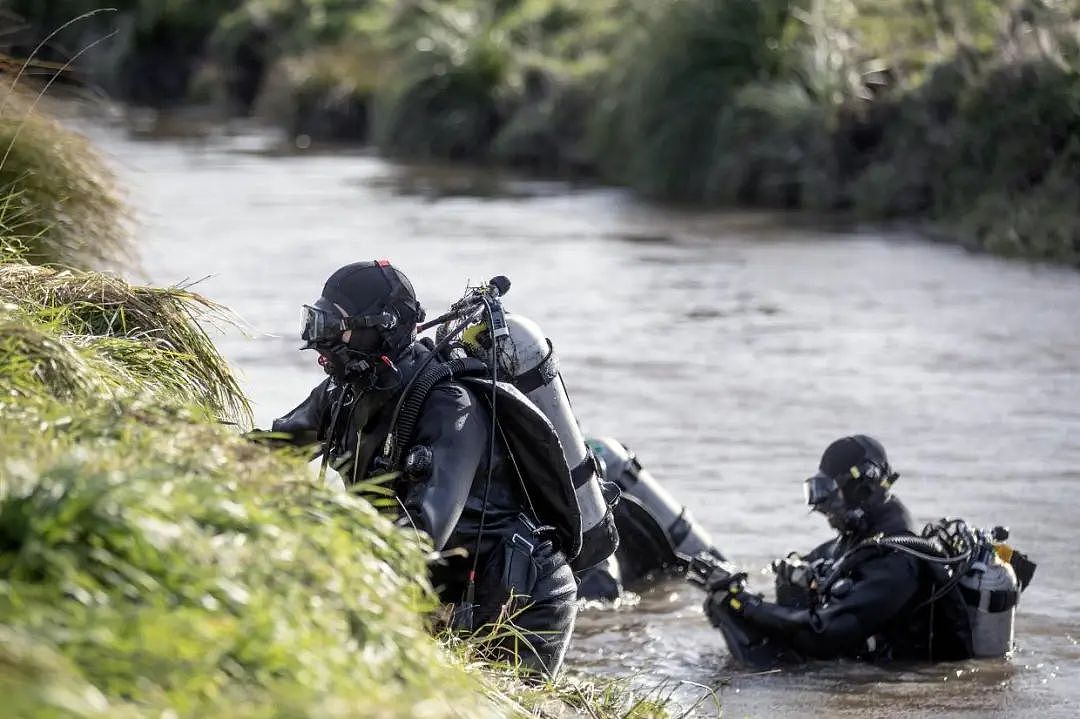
262, 260, 615, 676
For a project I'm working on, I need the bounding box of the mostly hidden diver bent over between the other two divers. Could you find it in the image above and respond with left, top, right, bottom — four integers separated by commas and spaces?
578, 437, 725, 601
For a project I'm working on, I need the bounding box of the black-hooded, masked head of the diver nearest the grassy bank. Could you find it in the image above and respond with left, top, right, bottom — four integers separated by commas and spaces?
300, 260, 424, 375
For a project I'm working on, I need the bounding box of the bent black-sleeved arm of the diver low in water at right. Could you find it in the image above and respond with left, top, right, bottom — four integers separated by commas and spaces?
742, 552, 919, 656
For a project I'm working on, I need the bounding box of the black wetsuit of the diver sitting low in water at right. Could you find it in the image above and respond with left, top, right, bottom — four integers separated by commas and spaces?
710, 498, 970, 661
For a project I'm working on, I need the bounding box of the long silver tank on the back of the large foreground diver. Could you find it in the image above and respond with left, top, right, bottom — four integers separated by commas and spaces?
461, 312, 619, 572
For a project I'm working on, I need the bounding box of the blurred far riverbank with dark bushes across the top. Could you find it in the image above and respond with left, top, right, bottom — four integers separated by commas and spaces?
13, 0, 1080, 266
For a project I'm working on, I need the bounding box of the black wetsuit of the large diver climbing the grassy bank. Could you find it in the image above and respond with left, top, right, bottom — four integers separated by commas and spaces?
273, 343, 577, 675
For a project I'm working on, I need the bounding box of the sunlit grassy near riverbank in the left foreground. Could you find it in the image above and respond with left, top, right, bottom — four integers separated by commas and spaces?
0, 85, 664, 717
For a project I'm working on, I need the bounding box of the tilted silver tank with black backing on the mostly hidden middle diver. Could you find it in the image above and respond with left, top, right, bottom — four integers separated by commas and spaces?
589, 437, 724, 583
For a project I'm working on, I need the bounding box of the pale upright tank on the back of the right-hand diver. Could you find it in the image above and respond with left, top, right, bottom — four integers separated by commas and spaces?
960, 553, 1020, 657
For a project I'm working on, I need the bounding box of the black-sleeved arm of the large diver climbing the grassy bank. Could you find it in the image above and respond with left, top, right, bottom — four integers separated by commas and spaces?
404, 382, 490, 550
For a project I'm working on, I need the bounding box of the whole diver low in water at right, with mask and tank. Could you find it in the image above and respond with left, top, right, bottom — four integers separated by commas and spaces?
690, 435, 1035, 667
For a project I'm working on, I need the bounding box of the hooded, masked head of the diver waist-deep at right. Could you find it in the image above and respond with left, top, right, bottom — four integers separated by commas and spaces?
805, 434, 900, 531
